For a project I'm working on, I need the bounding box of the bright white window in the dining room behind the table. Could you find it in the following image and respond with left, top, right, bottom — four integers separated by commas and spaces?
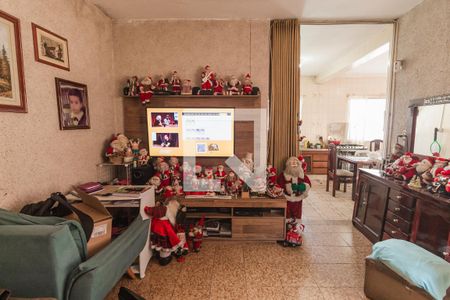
347, 98, 386, 143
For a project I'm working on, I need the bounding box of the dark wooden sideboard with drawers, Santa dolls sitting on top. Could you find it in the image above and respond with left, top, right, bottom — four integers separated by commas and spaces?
353, 169, 450, 260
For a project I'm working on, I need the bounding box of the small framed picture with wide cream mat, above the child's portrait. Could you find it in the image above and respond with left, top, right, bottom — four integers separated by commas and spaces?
31, 23, 70, 71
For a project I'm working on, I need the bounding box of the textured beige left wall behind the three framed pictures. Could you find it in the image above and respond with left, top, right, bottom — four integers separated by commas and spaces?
0, 0, 115, 209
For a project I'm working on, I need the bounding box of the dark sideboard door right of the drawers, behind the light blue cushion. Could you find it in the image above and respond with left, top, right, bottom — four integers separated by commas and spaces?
411, 199, 450, 256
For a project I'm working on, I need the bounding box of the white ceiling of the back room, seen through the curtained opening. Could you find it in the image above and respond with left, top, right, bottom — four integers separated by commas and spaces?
301, 24, 392, 77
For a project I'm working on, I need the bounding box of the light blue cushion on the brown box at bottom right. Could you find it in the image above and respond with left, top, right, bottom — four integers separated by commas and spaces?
368, 239, 450, 299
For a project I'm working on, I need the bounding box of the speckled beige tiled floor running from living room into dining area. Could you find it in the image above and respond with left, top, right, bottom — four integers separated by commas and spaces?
108, 177, 371, 300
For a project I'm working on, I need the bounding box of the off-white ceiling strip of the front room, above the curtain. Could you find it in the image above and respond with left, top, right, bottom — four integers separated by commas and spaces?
87, 0, 423, 20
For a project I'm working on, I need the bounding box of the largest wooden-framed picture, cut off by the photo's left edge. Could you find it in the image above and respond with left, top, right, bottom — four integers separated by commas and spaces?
0, 10, 27, 112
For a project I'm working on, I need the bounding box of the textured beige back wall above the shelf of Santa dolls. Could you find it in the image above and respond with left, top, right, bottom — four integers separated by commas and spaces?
113, 20, 270, 129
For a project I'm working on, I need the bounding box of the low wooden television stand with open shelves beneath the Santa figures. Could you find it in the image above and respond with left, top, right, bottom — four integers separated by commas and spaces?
178, 197, 286, 241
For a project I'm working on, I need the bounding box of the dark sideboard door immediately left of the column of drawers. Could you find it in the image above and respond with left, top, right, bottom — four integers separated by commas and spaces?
364, 181, 388, 242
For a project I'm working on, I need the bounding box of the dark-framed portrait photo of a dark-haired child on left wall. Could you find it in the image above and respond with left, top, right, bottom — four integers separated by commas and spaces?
55, 78, 91, 130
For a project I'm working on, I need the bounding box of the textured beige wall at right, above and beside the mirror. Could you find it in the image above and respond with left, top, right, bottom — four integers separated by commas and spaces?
391, 0, 450, 143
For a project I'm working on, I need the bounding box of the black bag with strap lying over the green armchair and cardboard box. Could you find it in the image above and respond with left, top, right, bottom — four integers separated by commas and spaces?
20, 192, 94, 241
